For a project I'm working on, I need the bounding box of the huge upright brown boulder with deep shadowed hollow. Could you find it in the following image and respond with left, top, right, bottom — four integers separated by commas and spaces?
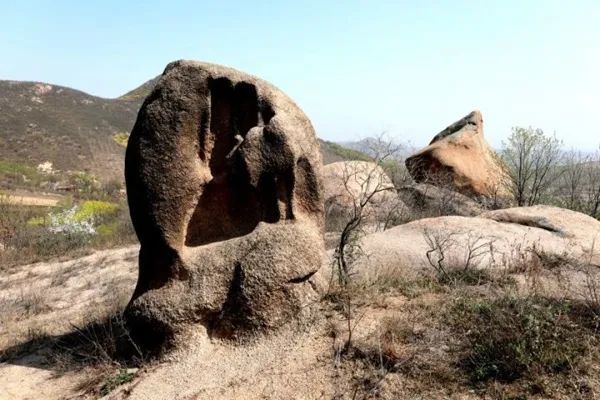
125, 61, 323, 345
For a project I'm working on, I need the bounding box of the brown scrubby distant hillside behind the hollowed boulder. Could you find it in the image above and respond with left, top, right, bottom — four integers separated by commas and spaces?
0, 77, 367, 181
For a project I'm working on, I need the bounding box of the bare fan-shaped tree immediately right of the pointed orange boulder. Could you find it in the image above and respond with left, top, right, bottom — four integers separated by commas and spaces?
501, 127, 562, 206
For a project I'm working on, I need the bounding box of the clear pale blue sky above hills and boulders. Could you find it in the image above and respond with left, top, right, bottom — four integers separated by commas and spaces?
0, 0, 600, 149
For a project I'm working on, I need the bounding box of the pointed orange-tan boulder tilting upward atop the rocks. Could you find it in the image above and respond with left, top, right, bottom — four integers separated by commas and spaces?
406, 111, 508, 197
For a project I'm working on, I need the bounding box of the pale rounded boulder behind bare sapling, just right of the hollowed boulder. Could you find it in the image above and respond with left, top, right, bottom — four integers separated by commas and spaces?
323, 161, 407, 230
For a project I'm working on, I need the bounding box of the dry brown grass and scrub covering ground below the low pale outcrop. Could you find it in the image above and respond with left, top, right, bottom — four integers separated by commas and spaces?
328, 241, 600, 399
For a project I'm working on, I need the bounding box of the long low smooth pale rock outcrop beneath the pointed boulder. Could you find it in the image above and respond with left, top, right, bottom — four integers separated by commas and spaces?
346, 206, 600, 282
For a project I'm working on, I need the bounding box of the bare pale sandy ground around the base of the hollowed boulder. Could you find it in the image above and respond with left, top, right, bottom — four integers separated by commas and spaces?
0, 246, 454, 400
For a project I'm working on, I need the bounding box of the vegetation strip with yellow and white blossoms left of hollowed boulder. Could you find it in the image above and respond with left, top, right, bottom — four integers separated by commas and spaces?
0, 195, 135, 270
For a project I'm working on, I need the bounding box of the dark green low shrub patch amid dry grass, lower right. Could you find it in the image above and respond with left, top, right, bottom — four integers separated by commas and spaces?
450, 295, 600, 383
